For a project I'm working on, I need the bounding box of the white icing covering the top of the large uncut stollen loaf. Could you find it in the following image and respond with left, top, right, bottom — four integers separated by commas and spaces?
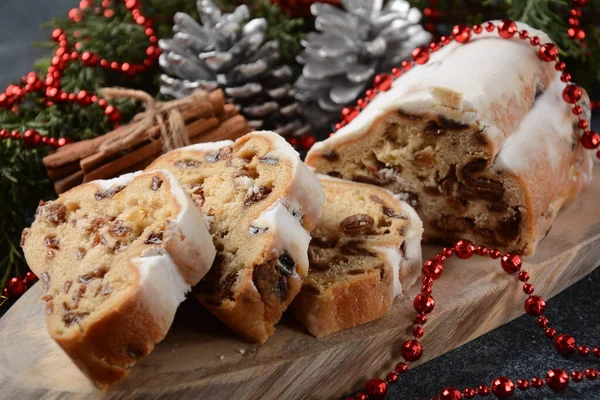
308, 22, 591, 178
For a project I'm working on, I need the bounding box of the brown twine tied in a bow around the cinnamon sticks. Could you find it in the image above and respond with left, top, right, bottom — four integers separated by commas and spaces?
100, 88, 208, 154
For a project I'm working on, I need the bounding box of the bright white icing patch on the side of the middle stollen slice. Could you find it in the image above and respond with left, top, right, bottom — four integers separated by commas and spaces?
252, 199, 310, 276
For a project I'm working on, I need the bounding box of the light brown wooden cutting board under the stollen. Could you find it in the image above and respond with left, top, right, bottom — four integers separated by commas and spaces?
0, 167, 600, 400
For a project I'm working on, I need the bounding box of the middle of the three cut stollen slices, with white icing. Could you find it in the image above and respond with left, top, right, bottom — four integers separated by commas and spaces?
147, 132, 325, 343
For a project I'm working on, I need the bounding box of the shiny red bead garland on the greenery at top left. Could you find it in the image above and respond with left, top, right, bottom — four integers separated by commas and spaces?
0, 0, 156, 148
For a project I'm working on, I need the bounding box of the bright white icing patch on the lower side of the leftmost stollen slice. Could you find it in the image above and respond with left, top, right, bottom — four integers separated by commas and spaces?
132, 253, 190, 331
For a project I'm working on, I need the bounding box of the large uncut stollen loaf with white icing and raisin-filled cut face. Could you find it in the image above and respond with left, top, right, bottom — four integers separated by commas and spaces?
306, 23, 592, 254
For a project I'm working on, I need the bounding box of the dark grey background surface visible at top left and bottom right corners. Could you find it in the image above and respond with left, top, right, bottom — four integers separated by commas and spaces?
0, 0, 600, 399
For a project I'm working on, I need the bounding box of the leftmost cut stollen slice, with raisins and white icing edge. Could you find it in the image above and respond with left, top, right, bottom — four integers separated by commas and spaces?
21, 171, 216, 389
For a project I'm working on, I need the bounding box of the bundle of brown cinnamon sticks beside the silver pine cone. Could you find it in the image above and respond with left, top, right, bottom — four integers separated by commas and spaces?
43, 89, 251, 194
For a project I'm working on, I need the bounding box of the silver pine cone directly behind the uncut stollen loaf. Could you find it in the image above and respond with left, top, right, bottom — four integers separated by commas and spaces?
295, 0, 431, 134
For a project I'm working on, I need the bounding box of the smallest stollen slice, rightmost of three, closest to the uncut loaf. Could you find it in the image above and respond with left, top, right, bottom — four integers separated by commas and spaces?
293, 175, 423, 337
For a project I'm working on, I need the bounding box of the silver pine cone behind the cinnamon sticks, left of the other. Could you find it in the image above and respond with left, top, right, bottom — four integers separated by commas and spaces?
159, 0, 308, 136
